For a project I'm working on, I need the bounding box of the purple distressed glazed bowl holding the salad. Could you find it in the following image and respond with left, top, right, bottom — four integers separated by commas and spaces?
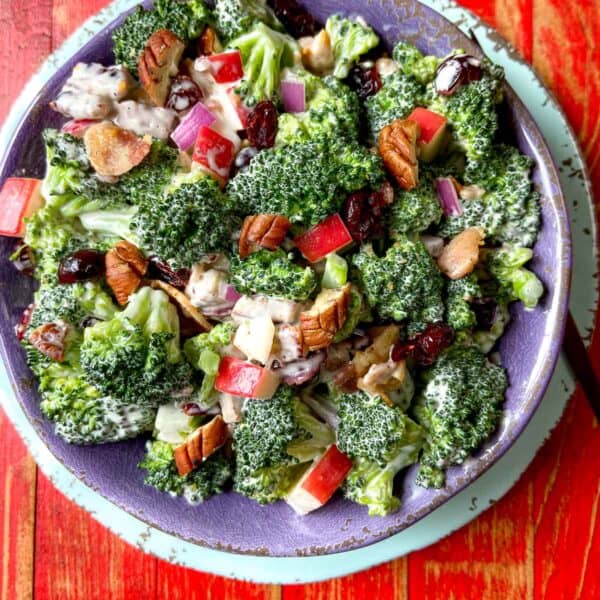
0, 0, 571, 556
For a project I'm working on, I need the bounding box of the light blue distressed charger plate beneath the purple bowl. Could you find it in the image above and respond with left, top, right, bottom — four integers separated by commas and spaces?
0, 0, 598, 583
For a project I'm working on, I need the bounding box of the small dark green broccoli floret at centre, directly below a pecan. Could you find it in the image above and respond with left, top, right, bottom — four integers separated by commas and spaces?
231, 250, 317, 301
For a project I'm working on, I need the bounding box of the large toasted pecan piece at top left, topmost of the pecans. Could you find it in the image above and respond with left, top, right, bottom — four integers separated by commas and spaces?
138, 29, 185, 106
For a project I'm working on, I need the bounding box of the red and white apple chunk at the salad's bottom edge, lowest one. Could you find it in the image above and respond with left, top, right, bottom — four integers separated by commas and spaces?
285, 445, 352, 515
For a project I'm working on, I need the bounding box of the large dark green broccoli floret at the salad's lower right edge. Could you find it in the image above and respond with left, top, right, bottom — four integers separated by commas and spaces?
414, 345, 507, 487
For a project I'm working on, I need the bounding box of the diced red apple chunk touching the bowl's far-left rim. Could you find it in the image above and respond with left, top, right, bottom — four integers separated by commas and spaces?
0, 177, 44, 237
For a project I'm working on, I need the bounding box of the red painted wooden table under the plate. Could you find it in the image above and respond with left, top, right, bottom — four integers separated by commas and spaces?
0, 0, 600, 600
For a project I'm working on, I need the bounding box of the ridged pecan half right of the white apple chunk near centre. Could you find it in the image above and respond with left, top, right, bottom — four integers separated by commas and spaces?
300, 283, 350, 354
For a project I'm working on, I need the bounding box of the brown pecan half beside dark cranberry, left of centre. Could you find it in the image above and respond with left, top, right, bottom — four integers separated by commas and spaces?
104, 241, 148, 306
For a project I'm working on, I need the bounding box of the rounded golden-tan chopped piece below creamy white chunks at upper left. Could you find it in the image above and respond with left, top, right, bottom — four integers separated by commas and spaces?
83, 122, 152, 177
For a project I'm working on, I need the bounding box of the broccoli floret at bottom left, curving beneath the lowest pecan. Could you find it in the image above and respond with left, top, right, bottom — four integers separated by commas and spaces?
138, 441, 231, 504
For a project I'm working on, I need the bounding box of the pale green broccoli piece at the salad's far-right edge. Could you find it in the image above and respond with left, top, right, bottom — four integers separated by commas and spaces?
485, 245, 544, 309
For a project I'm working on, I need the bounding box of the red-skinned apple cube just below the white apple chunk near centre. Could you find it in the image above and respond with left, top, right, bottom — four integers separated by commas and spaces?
215, 356, 279, 400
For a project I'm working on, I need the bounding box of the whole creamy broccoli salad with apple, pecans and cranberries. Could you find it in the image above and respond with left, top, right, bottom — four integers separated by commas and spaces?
0, 0, 543, 516
